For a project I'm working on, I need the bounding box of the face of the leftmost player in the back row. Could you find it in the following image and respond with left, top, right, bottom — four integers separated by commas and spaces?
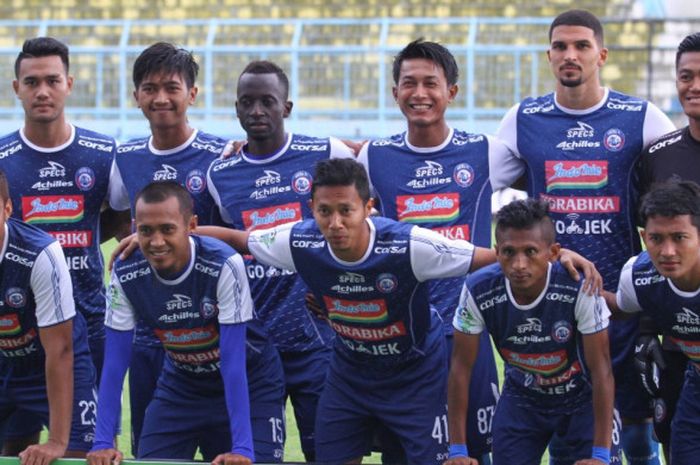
12, 55, 73, 124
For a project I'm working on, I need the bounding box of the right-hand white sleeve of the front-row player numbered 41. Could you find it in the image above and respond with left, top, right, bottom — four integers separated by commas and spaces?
410, 226, 474, 281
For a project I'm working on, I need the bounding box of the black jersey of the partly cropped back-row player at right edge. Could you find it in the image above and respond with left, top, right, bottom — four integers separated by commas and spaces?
639, 126, 700, 193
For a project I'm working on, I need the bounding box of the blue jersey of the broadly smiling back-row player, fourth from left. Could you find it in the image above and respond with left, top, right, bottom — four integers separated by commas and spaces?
358, 129, 499, 334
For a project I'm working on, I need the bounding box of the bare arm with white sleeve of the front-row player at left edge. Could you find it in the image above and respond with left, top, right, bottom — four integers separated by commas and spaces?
20, 242, 75, 465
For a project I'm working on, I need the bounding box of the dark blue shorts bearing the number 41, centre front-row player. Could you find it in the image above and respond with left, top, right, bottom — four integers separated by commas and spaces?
316, 337, 449, 465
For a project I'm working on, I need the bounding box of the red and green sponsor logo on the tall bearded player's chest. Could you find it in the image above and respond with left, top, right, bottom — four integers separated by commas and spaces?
544, 160, 608, 192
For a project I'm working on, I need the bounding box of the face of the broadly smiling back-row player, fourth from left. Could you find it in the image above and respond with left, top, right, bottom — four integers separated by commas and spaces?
393, 58, 457, 128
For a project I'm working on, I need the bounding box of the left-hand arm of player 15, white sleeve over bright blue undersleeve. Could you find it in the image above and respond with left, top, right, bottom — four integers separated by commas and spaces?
87, 272, 136, 465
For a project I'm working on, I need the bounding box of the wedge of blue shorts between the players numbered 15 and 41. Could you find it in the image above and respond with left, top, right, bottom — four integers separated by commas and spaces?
278, 347, 333, 456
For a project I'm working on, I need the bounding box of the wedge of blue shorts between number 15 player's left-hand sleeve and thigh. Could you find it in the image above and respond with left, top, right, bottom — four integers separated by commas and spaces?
129, 343, 165, 455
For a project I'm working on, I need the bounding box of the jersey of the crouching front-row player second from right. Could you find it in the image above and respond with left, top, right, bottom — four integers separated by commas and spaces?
454, 262, 610, 411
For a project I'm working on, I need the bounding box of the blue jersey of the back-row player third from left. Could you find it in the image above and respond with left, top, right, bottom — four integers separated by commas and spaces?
208, 134, 352, 352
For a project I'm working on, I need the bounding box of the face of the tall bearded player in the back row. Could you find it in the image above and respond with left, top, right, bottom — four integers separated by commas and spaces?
547, 25, 608, 87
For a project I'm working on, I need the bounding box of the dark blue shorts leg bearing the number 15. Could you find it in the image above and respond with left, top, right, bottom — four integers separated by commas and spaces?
249, 343, 286, 463
